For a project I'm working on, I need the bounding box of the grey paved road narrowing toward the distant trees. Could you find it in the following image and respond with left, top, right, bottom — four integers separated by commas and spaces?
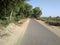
17, 19, 60, 45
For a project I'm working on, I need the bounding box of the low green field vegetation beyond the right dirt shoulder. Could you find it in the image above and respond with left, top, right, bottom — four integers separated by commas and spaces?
41, 16, 60, 26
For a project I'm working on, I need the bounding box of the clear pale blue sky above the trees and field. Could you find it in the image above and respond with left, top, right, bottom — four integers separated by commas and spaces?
28, 0, 60, 17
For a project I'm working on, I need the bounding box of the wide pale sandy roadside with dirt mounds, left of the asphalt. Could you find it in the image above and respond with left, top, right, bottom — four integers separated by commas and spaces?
0, 19, 29, 45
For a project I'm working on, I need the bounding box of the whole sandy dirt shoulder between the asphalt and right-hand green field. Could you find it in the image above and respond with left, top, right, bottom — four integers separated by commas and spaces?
36, 20, 60, 37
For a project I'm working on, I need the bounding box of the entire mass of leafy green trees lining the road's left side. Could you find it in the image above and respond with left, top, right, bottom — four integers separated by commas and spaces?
0, 0, 42, 25
